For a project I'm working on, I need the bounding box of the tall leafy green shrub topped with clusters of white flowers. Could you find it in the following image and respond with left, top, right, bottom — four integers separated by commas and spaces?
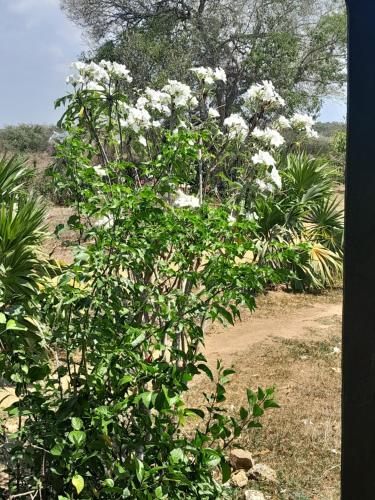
1, 61, 320, 500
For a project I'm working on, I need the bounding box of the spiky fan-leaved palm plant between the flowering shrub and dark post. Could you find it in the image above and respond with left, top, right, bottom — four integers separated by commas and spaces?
255, 153, 343, 290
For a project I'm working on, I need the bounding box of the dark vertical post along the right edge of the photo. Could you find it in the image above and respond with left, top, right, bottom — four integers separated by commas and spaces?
346, 0, 375, 500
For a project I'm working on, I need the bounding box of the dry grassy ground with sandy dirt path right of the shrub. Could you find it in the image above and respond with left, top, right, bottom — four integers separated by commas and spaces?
189, 289, 342, 500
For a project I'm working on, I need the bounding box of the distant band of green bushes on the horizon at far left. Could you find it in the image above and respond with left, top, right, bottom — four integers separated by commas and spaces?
0, 123, 56, 153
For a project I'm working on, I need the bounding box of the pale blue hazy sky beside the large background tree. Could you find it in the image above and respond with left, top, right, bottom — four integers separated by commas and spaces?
0, 0, 346, 126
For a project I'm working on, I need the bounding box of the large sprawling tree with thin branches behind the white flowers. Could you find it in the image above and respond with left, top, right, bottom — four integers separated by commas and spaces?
61, 0, 346, 117
